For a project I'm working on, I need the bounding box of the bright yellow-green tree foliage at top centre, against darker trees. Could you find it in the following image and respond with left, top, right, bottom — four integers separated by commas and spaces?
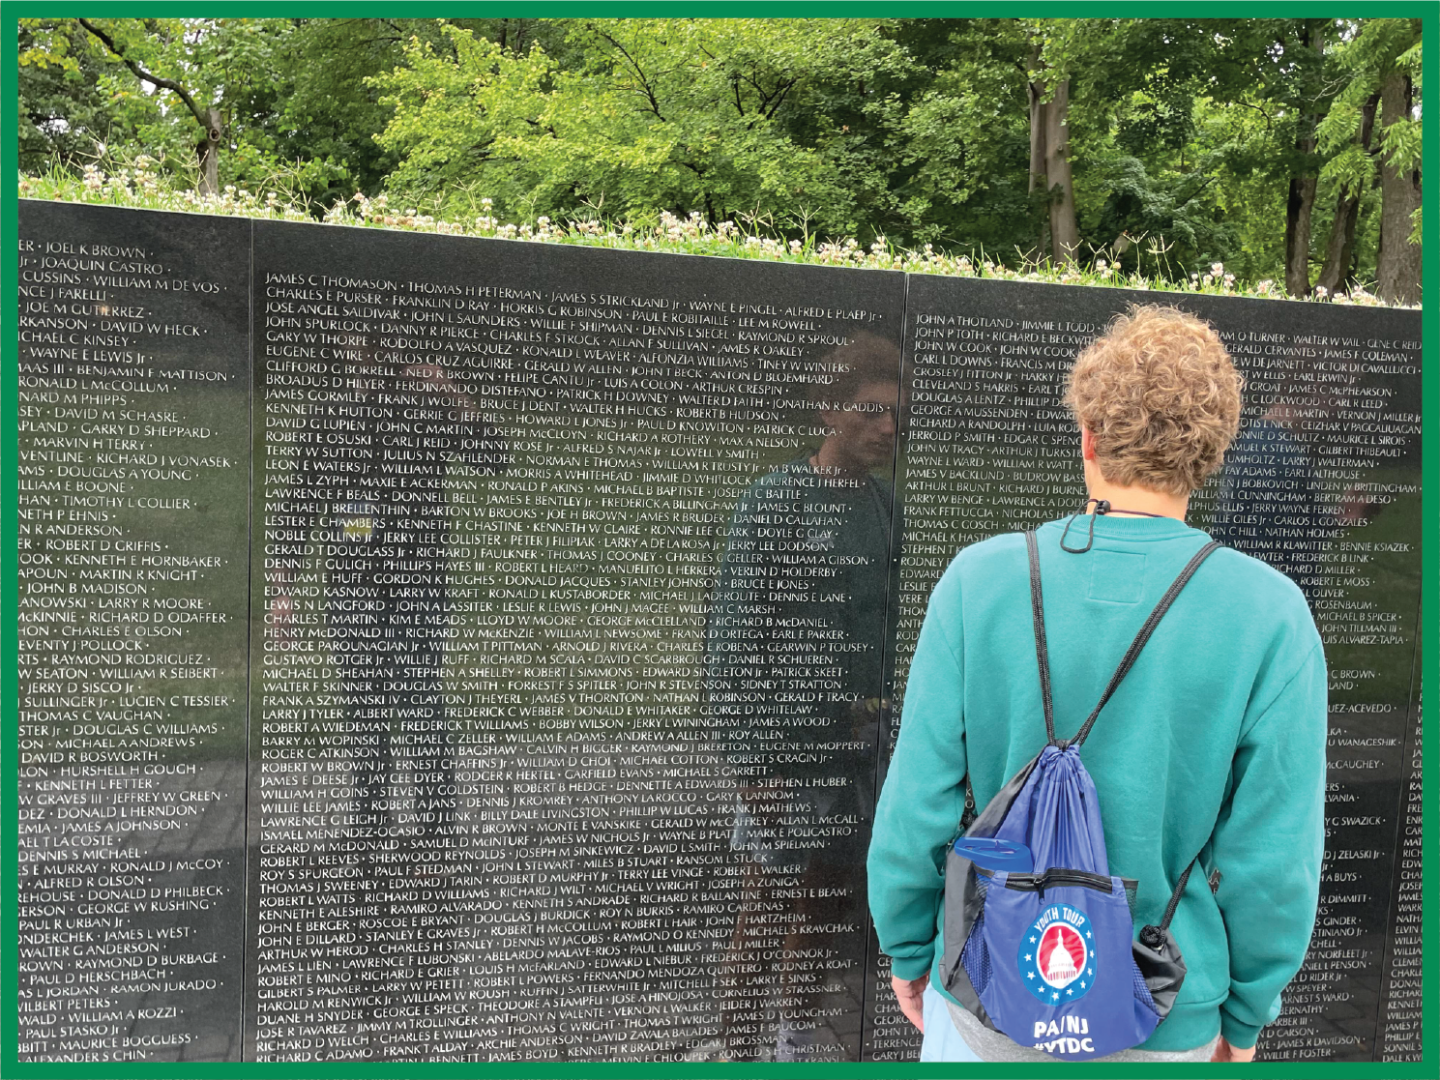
373, 19, 910, 230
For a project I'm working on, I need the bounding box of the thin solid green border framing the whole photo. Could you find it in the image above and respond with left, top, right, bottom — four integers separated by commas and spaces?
0, 0, 1440, 1080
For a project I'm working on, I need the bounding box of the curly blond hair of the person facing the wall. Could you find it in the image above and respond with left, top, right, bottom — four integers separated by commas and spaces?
1066, 305, 1244, 495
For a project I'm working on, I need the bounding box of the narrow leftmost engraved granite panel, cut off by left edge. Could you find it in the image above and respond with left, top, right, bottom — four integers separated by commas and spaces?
17, 203, 251, 1061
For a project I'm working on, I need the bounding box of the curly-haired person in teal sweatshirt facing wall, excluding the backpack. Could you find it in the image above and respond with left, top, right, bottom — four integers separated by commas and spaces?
868, 308, 1326, 1061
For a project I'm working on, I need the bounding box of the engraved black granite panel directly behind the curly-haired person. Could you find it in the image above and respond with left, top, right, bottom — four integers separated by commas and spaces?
875, 275, 1420, 1060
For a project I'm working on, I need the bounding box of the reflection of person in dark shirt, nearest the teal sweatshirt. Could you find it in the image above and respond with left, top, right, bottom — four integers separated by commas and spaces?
706, 336, 901, 1060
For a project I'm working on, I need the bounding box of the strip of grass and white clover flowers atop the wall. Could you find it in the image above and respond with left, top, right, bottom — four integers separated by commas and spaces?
19, 156, 1390, 307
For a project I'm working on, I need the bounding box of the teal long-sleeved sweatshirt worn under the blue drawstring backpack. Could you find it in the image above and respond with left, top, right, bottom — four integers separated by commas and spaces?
868, 517, 1328, 1050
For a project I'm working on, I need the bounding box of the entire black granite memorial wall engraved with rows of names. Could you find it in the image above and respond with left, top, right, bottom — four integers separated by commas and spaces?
19, 203, 1421, 1061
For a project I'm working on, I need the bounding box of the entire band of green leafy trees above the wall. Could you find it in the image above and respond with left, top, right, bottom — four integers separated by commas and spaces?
19, 19, 1421, 295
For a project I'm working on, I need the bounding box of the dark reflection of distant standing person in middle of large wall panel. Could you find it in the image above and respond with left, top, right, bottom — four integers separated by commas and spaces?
269, 348, 508, 842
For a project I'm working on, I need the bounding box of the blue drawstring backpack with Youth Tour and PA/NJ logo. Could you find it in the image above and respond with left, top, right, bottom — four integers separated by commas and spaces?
940, 531, 1220, 1061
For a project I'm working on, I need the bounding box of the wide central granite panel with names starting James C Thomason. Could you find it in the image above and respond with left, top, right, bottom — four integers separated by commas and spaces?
246, 223, 904, 1060
